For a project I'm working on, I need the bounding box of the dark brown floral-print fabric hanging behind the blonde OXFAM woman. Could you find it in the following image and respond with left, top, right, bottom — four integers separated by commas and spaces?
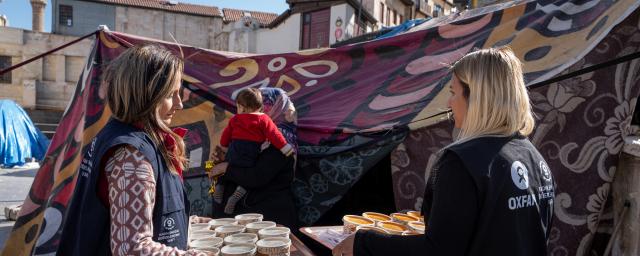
392, 11, 640, 255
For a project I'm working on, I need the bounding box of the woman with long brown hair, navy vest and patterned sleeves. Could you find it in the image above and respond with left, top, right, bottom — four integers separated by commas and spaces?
58, 45, 212, 255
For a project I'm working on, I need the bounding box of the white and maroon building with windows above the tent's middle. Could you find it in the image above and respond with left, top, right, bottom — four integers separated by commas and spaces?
251, 0, 455, 53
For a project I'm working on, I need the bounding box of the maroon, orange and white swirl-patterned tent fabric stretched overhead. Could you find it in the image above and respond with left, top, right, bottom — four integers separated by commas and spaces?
3, 0, 640, 255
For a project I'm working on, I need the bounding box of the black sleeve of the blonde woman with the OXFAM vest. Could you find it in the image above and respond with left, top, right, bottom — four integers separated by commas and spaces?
353, 152, 479, 255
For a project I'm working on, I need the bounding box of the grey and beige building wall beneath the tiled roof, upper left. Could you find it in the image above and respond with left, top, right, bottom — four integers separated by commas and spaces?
52, 0, 229, 50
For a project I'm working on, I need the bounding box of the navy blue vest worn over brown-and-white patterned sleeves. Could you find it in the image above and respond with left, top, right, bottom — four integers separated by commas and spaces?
58, 119, 189, 255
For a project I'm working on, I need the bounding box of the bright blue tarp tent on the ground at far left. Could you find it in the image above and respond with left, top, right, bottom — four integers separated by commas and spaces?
0, 100, 49, 167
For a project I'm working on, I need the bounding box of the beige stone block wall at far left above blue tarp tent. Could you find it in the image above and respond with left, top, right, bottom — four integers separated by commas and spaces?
0, 27, 92, 110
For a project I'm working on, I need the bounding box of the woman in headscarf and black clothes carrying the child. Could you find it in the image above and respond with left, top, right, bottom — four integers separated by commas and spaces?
211, 88, 297, 228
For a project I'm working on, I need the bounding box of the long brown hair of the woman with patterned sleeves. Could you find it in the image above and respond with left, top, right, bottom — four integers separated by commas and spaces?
103, 45, 186, 174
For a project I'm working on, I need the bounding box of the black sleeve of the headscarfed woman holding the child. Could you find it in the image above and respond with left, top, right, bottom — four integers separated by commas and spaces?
224, 146, 293, 189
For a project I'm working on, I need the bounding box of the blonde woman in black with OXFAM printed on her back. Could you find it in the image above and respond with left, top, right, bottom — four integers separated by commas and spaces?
333, 48, 554, 255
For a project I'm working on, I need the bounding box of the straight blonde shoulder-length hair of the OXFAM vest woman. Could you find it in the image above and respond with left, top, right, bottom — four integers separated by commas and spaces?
451, 47, 535, 141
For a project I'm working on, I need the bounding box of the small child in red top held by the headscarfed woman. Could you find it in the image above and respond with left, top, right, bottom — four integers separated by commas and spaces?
214, 88, 293, 214
